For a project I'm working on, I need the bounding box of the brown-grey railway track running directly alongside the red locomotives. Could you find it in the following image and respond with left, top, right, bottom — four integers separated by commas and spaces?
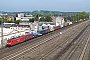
0, 23, 63, 57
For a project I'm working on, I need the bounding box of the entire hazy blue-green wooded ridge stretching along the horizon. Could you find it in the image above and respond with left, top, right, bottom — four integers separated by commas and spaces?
0, 10, 90, 16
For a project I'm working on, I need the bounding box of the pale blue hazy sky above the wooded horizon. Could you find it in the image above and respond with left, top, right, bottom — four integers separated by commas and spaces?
0, 0, 90, 12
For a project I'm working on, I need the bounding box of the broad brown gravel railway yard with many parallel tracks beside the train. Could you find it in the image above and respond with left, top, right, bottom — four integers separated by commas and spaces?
0, 20, 90, 60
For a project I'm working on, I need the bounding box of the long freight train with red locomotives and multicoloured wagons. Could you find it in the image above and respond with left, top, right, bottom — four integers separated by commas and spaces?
6, 19, 87, 46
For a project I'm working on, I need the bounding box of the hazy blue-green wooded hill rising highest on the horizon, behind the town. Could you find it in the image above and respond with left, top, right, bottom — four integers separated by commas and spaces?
31, 10, 80, 16
